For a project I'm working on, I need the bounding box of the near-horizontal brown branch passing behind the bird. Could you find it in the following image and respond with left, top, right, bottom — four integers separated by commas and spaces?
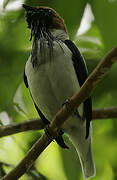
0, 107, 117, 137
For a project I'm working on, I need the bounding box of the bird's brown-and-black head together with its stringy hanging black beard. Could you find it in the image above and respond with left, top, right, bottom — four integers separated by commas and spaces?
23, 4, 67, 67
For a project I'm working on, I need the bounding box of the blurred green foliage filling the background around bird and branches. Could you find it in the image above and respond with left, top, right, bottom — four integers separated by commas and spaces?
0, 0, 117, 180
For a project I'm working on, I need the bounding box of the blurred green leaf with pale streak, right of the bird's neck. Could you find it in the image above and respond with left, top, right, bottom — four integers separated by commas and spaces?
75, 23, 104, 60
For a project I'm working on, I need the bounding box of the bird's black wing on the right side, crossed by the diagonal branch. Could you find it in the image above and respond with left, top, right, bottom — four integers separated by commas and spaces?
64, 40, 92, 138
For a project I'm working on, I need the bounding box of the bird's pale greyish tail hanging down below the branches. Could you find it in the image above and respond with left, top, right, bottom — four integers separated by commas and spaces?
68, 124, 95, 180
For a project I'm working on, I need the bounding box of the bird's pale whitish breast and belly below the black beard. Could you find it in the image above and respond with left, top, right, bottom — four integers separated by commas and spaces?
25, 42, 83, 120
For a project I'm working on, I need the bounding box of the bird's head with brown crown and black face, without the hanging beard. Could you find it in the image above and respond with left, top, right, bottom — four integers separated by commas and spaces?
23, 4, 66, 38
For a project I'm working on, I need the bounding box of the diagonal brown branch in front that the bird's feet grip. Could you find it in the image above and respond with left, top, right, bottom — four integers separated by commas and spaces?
2, 47, 117, 180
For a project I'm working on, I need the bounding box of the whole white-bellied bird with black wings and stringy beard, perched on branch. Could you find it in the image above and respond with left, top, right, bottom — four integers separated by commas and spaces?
23, 4, 95, 179
